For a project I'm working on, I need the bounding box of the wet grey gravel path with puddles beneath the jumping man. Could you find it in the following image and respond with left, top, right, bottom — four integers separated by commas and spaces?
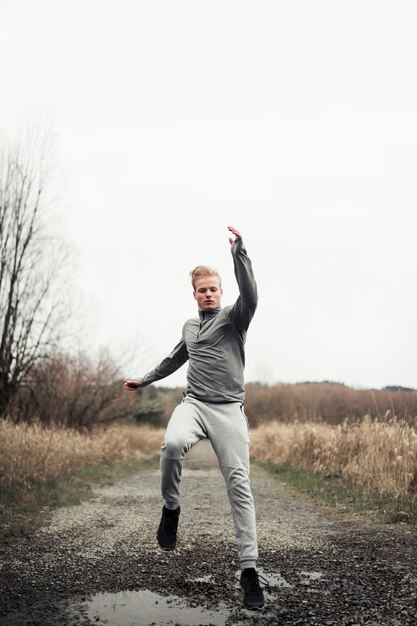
0, 443, 417, 626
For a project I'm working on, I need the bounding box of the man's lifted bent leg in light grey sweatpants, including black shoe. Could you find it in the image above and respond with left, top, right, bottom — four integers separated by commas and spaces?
157, 399, 206, 550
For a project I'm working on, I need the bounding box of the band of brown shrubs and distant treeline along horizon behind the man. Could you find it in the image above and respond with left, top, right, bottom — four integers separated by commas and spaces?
4, 354, 417, 430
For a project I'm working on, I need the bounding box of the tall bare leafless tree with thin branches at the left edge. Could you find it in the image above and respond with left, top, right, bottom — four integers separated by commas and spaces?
0, 134, 66, 416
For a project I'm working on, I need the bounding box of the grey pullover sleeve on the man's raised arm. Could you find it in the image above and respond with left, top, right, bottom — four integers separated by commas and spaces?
231, 237, 258, 331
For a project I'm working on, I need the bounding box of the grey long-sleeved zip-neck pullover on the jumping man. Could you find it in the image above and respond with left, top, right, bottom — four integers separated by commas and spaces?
138, 237, 258, 403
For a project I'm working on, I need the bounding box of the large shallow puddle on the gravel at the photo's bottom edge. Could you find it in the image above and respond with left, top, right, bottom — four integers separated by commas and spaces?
71, 590, 229, 626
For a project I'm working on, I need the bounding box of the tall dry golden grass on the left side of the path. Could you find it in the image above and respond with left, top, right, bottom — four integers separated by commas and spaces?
0, 420, 163, 485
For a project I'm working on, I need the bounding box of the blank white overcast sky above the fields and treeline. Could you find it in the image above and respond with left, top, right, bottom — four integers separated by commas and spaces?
0, 0, 417, 387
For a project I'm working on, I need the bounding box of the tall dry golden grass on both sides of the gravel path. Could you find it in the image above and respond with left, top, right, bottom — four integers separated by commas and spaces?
0, 417, 417, 498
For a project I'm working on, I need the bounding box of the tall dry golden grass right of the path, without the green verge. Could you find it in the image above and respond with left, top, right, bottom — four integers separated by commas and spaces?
251, 417, 417, 497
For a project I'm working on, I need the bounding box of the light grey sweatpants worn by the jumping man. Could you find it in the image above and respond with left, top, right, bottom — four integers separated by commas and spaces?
161, 396, 258, 569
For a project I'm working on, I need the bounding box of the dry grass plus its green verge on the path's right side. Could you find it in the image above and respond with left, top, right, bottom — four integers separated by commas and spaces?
251, 417, 417, 526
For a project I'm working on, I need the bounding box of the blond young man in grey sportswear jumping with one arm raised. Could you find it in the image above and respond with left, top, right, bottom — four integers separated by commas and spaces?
124, 226, 264, 609
